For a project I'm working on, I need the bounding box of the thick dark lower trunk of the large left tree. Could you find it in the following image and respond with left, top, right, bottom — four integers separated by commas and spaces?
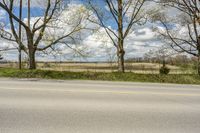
29, 48, 36, 70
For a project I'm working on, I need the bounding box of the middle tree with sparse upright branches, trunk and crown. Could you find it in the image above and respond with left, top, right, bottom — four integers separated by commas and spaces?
89, 0, 146, 72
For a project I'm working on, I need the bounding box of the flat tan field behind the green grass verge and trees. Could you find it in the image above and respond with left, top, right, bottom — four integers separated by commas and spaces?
0, 62, 195, 74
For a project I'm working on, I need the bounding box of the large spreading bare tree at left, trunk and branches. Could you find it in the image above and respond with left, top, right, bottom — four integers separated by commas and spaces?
0, 0, 85, 69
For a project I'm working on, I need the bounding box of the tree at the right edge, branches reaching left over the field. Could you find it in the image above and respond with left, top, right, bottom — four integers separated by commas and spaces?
154, 0, 200, 75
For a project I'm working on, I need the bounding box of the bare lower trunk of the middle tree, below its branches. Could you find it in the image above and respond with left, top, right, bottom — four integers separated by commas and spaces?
117, 50, 125, 73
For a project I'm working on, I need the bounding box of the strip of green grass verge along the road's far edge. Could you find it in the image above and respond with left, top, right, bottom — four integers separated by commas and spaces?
0, 68, 200, 84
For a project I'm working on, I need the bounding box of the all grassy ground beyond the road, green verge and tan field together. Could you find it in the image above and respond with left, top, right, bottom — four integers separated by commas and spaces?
0, 62, 200, 84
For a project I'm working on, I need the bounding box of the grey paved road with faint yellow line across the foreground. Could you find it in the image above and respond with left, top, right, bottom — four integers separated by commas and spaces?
0, 79, 200, 133
